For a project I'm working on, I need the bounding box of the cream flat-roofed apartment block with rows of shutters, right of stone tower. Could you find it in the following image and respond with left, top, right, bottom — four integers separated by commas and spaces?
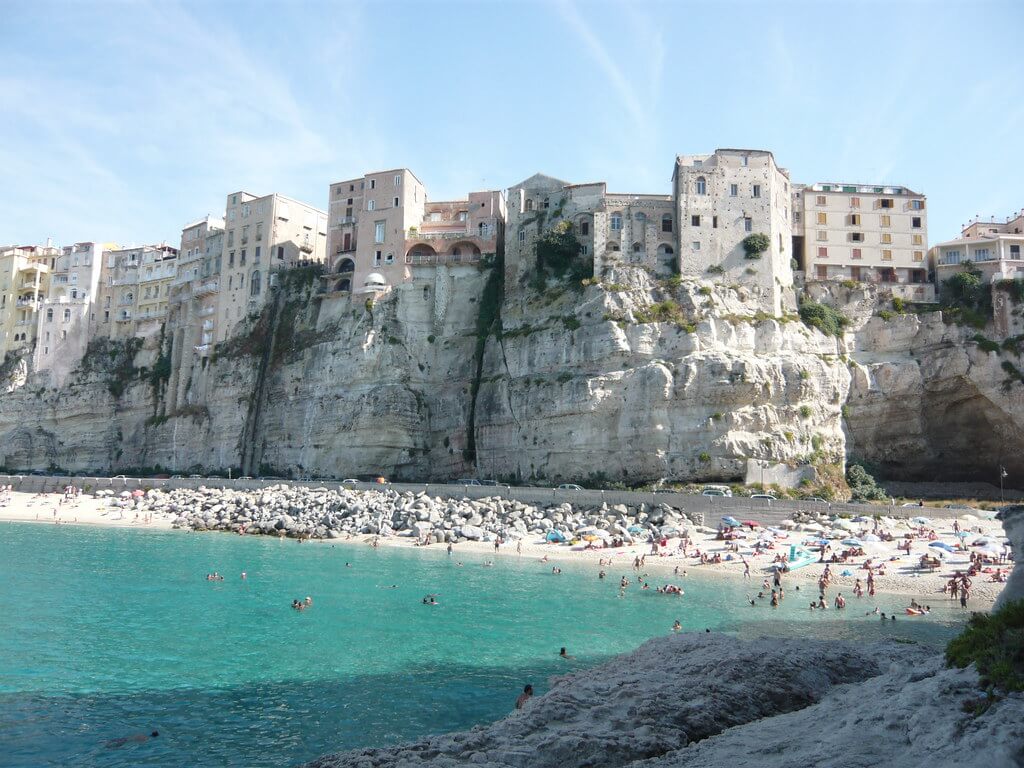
793, 183, 935, 301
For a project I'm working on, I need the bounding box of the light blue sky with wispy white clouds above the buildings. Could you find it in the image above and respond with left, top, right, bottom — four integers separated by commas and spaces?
0, 0, 1024, 244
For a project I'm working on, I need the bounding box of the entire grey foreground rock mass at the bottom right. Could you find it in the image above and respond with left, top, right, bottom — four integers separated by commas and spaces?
308, 633, 1024, 768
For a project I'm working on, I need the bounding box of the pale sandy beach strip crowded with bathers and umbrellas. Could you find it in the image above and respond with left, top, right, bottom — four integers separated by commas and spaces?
0, 492, 1013, 609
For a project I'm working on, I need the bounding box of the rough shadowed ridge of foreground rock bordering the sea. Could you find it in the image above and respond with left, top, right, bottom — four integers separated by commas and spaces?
301, 633, 950, 768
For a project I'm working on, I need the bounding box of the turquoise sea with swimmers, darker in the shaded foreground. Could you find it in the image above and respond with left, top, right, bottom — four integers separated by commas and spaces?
0, 523, 964, 767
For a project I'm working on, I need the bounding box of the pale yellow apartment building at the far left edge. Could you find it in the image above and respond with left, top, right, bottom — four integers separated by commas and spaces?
0, 245, 59, 362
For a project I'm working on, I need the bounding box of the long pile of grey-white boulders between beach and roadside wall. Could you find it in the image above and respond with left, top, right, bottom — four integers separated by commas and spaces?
114, 485, 703, 543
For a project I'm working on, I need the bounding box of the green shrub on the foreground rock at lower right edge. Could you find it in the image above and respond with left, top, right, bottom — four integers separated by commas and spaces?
946, 600, 1024, 691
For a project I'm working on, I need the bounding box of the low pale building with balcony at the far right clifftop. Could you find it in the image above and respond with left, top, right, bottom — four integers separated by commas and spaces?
929, 210, 1024, 291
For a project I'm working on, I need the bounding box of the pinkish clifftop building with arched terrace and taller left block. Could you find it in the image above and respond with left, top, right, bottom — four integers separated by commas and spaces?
325, 168, 505, 292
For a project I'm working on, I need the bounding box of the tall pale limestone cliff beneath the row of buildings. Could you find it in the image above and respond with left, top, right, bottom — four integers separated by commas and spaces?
0, 265, 1024, 482
